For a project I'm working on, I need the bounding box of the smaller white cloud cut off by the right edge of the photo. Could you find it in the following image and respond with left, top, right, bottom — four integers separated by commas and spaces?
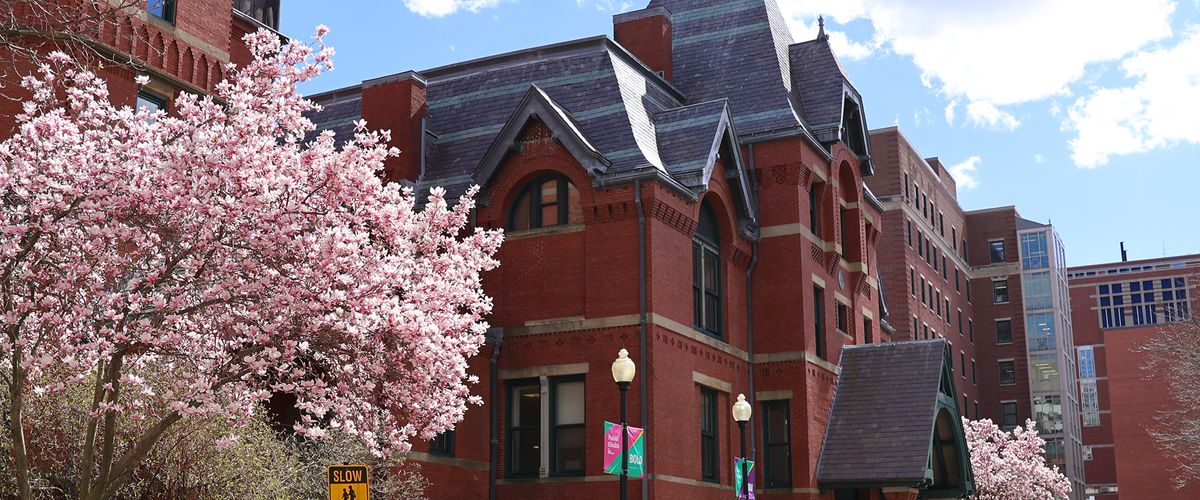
1064, 26, 1200, 168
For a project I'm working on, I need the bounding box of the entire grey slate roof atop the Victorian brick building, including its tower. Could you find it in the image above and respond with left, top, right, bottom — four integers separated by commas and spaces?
302, 0, 873, 222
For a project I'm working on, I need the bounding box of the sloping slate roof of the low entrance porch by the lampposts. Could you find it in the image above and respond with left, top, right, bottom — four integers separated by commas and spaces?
817, 339, 946, 487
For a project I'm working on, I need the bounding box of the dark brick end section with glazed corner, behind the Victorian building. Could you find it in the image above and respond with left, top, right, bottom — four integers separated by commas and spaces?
966, 206, 1085, 499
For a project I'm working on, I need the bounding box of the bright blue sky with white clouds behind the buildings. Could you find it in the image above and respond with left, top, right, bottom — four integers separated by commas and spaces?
281, 0, 1200, 265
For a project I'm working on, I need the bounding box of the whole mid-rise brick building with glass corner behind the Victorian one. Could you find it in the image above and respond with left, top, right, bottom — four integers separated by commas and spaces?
866, 127, 1084, 499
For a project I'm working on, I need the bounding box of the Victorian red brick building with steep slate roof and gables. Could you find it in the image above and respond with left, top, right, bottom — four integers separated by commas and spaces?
313, 0, 971, 499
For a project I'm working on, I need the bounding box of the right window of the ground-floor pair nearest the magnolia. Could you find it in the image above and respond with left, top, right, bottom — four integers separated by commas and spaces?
550, 376, 586, 476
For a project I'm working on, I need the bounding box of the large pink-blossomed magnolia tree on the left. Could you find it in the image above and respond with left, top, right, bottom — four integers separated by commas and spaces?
0, 26, 502, 499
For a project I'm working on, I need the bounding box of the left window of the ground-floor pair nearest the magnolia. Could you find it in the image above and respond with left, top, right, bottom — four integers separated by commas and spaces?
506, 379, 541, 476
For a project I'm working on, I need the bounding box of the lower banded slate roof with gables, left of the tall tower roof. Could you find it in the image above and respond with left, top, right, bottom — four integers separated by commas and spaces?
311, 37, 756, 223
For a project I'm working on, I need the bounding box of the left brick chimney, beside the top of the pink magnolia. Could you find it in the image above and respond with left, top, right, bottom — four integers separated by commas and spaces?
362, 71, 426, 182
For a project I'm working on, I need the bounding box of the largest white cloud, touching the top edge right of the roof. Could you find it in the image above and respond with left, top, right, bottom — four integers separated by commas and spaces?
780, 0, 1175, 128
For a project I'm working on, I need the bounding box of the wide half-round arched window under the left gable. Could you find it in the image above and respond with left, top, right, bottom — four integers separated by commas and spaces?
509, 174, 583, 231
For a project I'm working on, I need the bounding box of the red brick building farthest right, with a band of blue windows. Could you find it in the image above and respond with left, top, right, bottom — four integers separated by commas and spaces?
1069, 255, 1200, 499
